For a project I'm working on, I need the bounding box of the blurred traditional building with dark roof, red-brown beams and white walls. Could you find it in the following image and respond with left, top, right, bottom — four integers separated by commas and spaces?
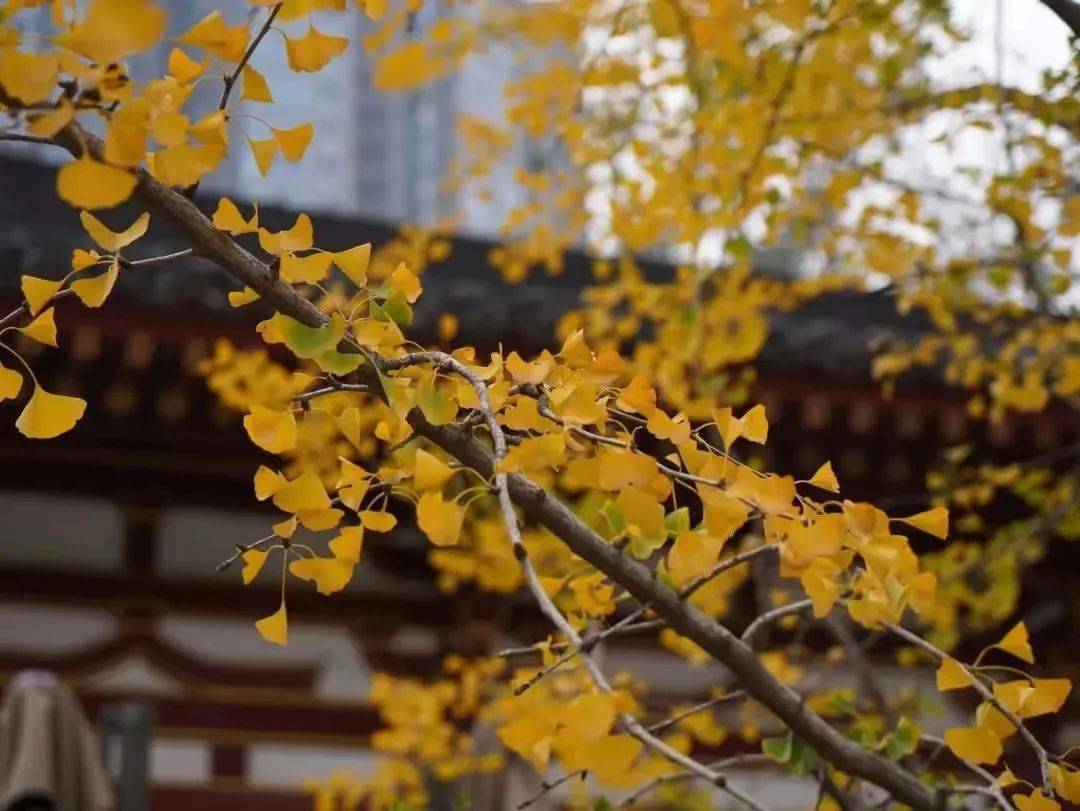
0, 153, 1080, 811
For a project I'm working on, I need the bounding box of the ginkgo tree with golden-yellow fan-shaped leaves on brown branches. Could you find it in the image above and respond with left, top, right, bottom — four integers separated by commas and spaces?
0, 0, 1080, 811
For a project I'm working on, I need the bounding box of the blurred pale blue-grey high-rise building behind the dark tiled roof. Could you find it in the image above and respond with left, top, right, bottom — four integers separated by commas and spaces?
0, 0, 527, 235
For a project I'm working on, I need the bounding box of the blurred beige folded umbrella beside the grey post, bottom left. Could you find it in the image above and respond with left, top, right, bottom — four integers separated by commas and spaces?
0, 671, 116, 811
